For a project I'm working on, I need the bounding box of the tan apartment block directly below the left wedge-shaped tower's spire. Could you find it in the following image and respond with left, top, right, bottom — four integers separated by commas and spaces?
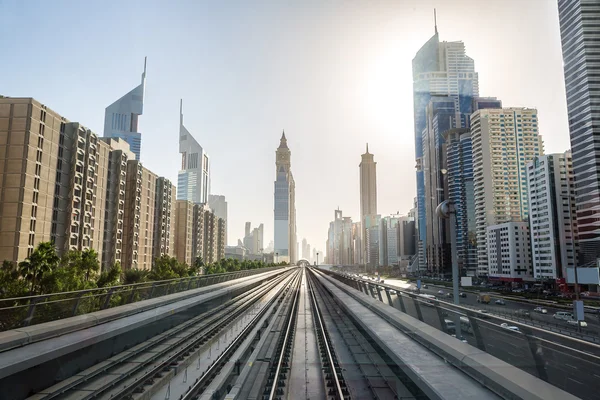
122, 160, 157, 269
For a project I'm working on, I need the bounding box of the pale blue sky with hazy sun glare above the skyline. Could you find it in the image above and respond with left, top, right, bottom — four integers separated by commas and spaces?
0, 0, 570, 255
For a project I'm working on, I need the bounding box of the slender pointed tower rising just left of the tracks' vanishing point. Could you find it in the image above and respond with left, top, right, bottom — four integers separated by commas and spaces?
274, 132, 297, 263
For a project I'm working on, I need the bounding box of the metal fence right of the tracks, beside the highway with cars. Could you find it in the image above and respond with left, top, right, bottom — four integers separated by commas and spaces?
321, 270, 600, 399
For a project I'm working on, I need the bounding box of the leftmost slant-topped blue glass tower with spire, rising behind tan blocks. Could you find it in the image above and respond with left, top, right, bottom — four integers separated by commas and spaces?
104, 59, 146, 160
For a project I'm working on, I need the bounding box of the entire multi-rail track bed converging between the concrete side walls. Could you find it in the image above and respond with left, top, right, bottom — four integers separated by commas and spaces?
35, 268, 427, 400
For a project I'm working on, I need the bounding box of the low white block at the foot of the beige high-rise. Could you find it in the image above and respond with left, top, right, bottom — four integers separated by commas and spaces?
486, 222, 533, 282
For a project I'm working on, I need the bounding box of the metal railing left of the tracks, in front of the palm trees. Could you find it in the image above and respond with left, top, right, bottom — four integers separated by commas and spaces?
0, 267, 282, 332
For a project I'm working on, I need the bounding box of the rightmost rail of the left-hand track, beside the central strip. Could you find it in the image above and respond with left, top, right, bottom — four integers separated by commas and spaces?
180, 270, 300, 400
